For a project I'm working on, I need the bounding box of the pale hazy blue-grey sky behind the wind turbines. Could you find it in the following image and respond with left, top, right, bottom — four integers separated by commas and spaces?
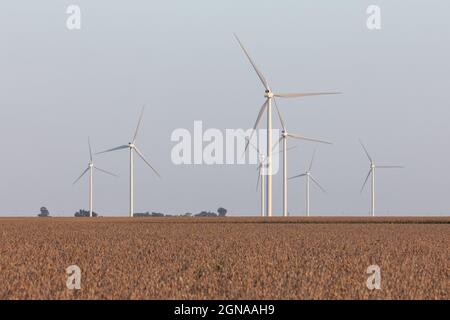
0, 0, 450, 216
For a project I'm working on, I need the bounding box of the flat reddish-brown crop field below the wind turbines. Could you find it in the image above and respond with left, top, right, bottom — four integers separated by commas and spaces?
0, 218, 450, 299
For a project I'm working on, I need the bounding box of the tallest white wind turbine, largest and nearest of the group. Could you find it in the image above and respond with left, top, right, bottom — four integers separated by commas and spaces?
234, 34, 340, 217
